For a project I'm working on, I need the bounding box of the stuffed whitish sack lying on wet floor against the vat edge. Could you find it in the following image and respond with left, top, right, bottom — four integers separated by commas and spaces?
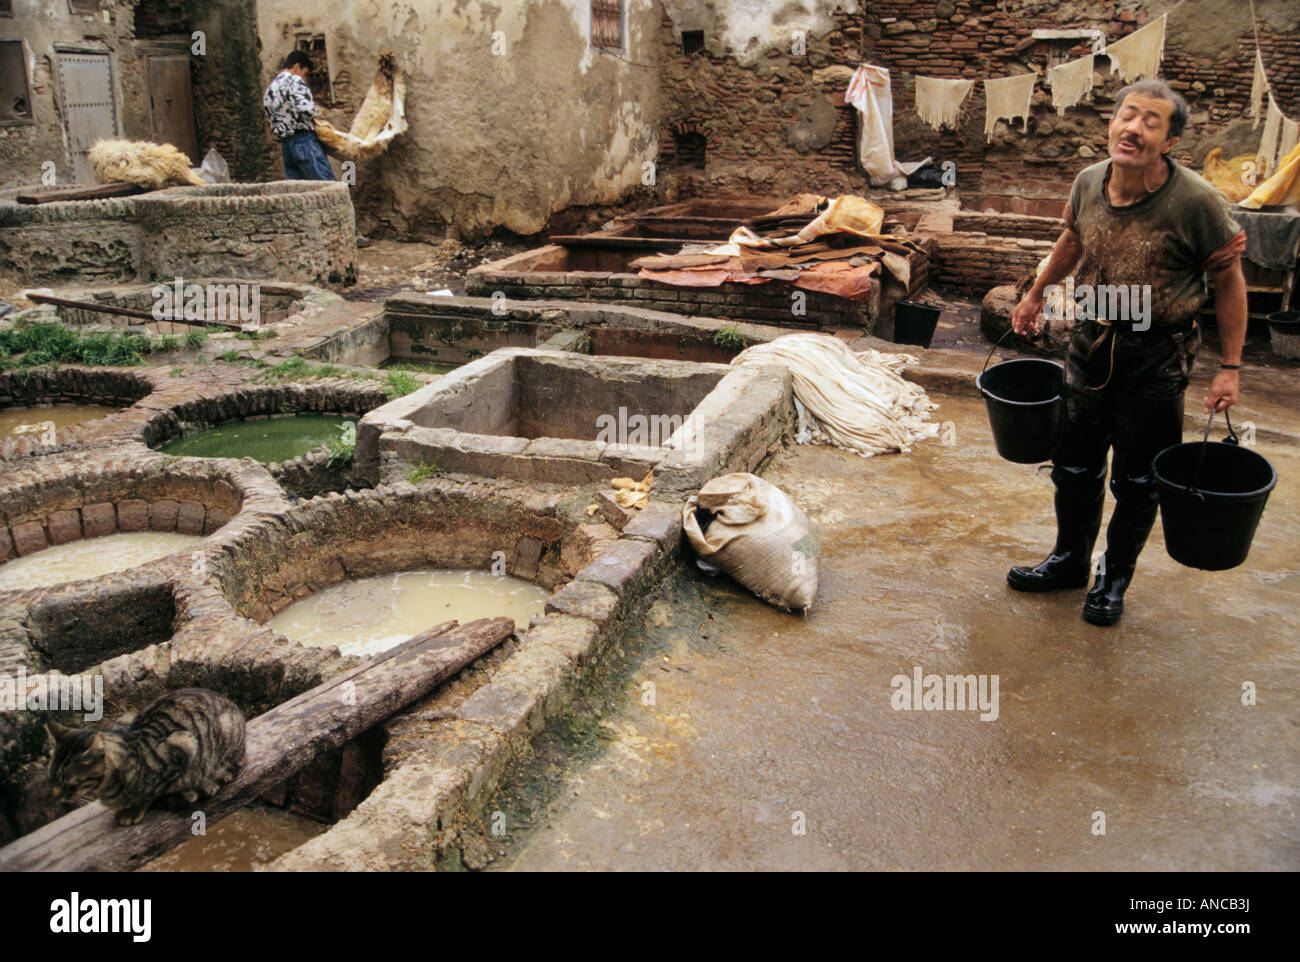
681, 473, 820, 611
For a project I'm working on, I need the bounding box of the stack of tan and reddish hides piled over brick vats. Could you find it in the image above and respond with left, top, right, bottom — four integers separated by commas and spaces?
632, 194, 923, 300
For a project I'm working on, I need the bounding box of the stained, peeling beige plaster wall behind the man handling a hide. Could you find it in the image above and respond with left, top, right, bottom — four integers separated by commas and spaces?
249, 0, 659, 238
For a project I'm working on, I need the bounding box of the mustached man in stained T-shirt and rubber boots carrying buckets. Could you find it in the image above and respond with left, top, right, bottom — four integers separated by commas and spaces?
1006, 79, 1247, 625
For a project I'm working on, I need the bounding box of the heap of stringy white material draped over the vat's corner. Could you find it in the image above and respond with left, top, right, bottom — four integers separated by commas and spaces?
732, 334, 940, 458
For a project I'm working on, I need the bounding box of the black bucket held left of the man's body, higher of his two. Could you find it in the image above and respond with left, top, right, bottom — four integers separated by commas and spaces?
975, 332, 1065, 464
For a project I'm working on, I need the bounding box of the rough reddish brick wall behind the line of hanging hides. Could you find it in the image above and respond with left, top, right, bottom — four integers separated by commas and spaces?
659, 0, 1300, 196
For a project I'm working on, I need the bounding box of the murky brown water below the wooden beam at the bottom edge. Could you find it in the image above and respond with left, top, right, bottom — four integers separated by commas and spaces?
140, 807, 329, 872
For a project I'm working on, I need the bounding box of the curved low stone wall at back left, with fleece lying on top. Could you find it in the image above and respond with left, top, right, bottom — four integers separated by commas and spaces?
0, 181, 356, 285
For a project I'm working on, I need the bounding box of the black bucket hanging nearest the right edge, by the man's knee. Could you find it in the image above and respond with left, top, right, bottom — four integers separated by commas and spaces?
1152, 413, 1278, 571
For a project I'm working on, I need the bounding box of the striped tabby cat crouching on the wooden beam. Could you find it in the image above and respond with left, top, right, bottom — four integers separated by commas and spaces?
47, 688, 244, 826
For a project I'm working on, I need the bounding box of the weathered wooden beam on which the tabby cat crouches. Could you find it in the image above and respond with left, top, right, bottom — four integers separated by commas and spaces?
0, 618, 515, 872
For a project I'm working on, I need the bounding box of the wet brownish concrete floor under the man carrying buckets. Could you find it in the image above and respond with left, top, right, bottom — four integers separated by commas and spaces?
485, 397, 1300, 871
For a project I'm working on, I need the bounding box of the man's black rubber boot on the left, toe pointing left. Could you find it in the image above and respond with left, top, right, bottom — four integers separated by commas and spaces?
1006, 467, 1106, 592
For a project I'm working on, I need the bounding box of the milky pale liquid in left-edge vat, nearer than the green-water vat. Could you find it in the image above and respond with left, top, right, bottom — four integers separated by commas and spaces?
0, 532, 203, 590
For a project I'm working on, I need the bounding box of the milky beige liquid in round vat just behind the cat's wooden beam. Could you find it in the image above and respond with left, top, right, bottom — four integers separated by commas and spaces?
269, 569, 549, 657
